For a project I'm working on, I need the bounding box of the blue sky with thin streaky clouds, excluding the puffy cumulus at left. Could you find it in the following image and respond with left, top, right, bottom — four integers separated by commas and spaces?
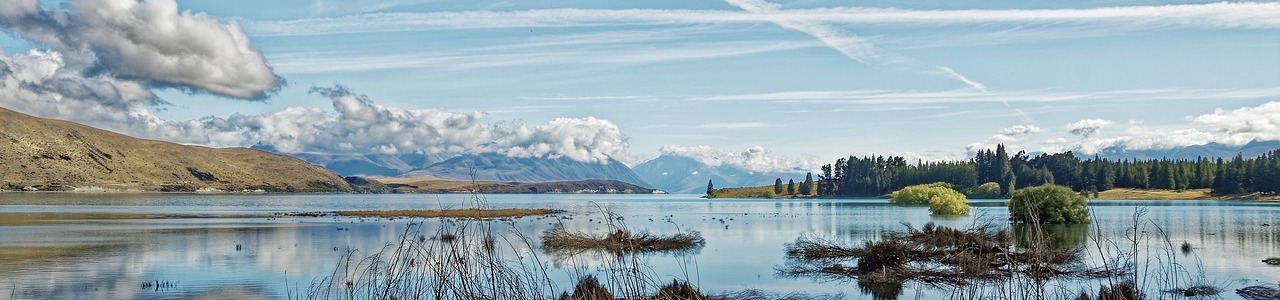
4, 0, 1280, 169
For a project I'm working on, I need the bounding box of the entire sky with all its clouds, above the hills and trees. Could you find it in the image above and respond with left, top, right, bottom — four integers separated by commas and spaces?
0, 0, 1280, 169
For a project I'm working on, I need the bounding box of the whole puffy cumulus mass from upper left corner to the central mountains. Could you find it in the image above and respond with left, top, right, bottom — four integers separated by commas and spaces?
0, 0, 627, 163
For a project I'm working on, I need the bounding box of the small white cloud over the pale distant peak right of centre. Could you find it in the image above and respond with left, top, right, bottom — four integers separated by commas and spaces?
659, 145, 820, 173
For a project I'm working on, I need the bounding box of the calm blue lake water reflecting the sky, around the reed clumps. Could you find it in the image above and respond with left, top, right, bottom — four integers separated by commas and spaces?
0, 194, 1280, 299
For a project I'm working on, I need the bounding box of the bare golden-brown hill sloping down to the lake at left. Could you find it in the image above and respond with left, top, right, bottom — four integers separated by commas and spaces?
0, 108, 352, 192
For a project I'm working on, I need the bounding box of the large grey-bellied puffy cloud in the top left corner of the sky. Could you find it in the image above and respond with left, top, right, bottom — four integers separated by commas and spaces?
0, 0, 284, 100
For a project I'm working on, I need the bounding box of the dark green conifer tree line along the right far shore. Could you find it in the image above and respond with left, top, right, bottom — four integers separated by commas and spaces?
803, 145, 1280, 196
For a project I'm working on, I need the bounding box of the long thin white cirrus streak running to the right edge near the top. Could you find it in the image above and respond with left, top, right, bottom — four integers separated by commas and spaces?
243, 3, 1280, 36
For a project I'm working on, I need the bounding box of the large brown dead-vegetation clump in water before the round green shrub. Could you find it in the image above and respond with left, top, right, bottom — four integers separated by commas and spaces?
781, 223, 1096, 285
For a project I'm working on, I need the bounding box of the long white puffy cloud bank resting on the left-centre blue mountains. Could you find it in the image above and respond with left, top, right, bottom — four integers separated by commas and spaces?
201, 86, 627, 163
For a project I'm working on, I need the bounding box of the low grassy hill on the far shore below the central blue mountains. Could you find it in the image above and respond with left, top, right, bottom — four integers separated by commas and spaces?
378, 178, 654, 194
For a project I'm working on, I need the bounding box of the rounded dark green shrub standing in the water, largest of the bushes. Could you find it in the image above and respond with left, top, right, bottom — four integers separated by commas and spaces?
1009, 185, 1089, 224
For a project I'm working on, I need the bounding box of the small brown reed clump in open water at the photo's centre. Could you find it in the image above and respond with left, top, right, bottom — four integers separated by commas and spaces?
541, 224, 707, 254
